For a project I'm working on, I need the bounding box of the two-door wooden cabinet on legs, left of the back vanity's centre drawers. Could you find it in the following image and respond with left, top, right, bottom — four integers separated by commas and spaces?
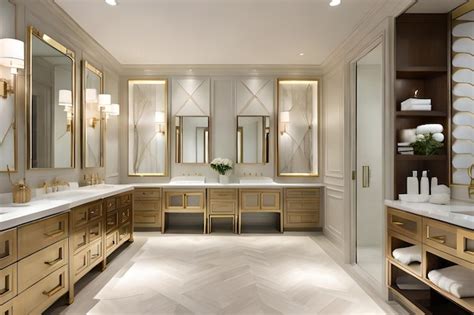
161, 189, 207, 233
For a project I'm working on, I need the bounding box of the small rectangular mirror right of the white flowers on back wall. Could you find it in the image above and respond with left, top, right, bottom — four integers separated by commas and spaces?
237, 116, 270, 164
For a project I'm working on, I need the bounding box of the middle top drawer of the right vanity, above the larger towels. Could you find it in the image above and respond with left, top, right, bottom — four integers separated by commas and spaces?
423, 218, 457, 256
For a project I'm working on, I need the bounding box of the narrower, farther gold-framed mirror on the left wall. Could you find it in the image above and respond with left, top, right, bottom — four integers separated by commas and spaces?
81, 60, 105, 168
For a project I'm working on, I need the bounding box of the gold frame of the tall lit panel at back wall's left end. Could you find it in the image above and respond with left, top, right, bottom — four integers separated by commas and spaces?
127, 78, 170, 177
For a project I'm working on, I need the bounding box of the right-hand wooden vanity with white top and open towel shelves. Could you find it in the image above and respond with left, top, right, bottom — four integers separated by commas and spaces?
386, 201, 474, 314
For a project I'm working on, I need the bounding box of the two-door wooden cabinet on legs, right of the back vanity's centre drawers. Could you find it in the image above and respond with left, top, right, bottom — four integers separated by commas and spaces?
238, 189, 283, 233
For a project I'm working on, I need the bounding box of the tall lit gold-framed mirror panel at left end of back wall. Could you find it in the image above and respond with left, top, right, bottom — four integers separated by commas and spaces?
128, 80, 168, 176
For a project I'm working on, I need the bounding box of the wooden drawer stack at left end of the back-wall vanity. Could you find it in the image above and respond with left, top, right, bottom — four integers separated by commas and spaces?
134, 188, 161, 229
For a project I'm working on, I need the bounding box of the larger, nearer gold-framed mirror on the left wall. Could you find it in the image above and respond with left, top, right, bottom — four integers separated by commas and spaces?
26, 27, 75, 169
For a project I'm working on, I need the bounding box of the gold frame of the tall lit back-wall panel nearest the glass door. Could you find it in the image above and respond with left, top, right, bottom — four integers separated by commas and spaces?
275, 78, 321, 177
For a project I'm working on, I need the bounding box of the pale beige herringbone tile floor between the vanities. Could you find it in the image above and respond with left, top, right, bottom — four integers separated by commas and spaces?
50, 233, 384, 314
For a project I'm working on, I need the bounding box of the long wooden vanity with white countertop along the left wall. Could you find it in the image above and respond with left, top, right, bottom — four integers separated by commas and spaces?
0, 185, 133, 314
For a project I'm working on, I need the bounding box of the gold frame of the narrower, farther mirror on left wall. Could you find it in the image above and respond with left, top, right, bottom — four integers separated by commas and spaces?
81, 60, 106, 169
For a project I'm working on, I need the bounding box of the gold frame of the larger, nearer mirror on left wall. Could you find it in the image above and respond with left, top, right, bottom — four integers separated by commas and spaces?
25, 26, 76, 170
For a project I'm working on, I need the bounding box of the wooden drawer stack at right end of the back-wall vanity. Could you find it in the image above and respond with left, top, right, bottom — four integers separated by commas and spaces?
284, 188, 321, 230
